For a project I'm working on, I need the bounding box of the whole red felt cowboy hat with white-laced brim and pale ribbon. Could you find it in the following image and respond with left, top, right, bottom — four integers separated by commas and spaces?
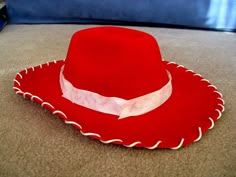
13, 27, 224, 149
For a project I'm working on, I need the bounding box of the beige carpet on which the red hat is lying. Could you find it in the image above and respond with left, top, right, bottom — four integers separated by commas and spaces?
0, 25, 236, 177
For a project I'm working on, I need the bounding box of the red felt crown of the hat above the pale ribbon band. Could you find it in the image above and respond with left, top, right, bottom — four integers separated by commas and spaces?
63, 27, 168, 99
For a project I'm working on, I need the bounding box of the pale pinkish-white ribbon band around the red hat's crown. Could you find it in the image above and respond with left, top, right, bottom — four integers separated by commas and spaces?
60, 66, 172, 119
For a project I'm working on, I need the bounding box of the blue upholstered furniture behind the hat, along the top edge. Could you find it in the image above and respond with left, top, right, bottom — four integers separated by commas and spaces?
6, 0, 236, 30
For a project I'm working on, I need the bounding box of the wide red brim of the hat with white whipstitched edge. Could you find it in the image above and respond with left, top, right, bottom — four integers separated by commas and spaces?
13, 60, 224, 149
